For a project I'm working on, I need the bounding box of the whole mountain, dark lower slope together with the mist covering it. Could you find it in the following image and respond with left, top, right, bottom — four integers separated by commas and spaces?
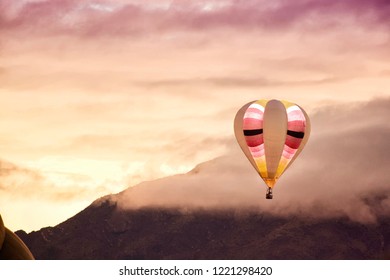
18, 99, 390, 259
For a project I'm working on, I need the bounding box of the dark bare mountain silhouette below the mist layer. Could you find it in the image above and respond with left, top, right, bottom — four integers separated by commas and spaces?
17, 197, 390, 259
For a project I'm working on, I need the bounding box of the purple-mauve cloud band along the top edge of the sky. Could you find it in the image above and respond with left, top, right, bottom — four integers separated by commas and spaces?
0, 0, 390, 37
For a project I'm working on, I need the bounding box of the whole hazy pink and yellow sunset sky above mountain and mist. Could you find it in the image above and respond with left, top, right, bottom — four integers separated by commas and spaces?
0, 0, 390, 231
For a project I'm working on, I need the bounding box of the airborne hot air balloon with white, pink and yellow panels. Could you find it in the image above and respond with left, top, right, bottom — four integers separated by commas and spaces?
234, 99, 310, 199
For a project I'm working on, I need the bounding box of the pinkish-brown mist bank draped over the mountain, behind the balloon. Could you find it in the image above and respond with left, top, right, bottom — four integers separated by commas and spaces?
111, 98, 390, 223
